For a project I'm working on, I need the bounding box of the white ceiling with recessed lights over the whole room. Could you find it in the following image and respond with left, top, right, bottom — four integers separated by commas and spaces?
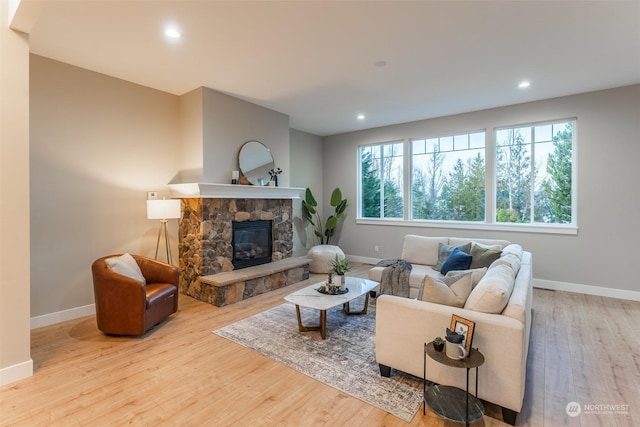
14, 0, 640, 136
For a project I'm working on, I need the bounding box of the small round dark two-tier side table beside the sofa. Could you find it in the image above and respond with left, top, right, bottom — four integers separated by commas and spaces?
422, 342, 484, 427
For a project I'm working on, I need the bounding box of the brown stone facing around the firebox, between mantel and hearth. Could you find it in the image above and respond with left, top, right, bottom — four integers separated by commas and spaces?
178, 198, 293, 302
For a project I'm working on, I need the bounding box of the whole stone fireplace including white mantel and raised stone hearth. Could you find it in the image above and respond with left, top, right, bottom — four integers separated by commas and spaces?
170, 183, 309, 307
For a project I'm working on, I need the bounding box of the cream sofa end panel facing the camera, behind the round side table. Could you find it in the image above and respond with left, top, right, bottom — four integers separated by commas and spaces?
376, 295, 528, 412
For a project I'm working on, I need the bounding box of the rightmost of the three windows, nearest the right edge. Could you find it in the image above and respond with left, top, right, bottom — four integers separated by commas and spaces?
495, 122, 574, 224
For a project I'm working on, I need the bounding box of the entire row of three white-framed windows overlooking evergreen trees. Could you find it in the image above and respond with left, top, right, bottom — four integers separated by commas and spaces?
358, 120, 576, 233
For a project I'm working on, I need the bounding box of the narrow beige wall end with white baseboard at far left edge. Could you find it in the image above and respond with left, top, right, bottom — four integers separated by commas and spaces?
0, 1, 33, 385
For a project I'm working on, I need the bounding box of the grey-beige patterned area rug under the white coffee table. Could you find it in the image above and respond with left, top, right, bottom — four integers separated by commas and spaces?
213, 300, 422, 422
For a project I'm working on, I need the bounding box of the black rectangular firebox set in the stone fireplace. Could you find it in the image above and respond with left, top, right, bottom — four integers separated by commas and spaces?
231, 220, 273, 270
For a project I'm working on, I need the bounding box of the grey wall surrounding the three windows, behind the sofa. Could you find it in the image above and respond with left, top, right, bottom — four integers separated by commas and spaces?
324, 85, 640, 297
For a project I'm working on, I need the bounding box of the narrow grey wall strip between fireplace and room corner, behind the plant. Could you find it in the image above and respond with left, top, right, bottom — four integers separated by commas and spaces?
289, 129, 326, 256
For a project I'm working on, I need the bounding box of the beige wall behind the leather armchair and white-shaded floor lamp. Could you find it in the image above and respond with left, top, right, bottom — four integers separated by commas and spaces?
25, 55, 179, 317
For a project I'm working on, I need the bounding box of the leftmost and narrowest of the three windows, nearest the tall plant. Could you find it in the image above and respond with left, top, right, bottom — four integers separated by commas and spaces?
359, 141, 404, 218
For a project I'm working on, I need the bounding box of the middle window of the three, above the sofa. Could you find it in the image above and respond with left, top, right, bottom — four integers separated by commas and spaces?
411, 132, 485, 221
